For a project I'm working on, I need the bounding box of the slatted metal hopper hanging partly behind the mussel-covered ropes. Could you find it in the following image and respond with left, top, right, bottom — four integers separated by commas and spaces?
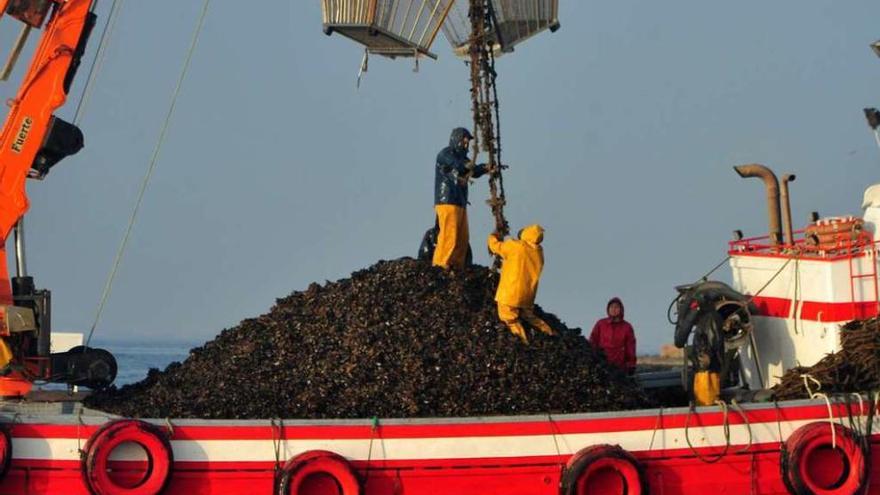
443, 0, 559, 58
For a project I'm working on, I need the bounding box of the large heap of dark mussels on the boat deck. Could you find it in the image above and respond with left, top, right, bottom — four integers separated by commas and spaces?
86, 258, 646, 419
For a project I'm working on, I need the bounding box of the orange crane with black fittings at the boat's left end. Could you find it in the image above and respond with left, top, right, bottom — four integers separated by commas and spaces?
0, 0, 116, 396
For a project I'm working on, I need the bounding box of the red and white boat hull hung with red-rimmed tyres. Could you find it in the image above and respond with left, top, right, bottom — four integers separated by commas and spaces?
0, 401, 880, 495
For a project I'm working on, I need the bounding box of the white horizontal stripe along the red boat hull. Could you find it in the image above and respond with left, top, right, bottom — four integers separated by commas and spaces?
13, 420, 840, 462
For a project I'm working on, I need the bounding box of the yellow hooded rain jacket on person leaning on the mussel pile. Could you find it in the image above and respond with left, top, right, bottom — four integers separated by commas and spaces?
489, 225, 544, 308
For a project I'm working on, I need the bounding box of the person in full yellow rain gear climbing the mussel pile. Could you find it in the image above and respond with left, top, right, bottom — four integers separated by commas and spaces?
489, 225, 556, 344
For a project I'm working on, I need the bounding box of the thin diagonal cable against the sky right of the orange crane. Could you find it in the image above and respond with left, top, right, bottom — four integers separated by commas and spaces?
83, 0, 211, 352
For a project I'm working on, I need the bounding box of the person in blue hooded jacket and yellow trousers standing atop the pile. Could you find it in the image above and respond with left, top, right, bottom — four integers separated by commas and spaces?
432, 127, 488, 268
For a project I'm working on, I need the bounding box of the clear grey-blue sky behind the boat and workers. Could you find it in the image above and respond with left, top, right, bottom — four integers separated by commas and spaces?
0, 0, 880, 353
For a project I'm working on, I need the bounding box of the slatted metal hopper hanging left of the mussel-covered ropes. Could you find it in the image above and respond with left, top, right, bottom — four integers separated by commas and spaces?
321, 0, 455, 58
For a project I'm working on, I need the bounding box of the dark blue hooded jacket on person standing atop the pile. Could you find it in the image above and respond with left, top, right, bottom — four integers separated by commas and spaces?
434, 127, 486, 208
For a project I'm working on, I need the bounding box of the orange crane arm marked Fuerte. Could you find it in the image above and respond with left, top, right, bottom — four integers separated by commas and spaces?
0, 0, 95, 305
